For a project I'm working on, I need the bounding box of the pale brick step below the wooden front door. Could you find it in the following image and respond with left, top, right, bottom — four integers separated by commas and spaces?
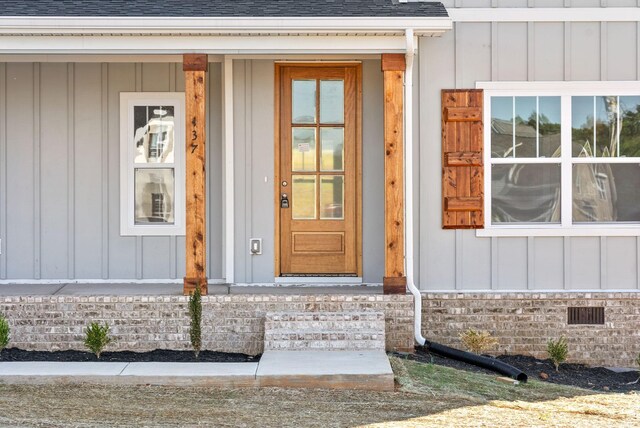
264, 312, 385, 351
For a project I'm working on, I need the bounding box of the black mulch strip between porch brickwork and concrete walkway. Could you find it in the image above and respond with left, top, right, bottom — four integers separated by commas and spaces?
0, 348, 260, 363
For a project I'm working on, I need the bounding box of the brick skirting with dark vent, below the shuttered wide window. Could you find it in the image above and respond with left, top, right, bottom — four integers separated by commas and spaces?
422, 292, 640, 367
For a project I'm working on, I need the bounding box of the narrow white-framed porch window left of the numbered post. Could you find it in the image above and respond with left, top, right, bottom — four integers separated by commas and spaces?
120, 93, 185, 235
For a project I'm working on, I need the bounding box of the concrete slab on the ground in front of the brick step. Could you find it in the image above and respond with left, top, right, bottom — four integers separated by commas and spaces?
256, 350, 395, 391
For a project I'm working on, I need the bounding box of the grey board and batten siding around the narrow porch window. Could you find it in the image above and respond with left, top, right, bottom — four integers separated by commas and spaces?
0, 63, 222, 280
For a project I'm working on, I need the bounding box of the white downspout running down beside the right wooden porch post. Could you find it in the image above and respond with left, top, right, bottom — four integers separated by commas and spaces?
404, 28, 426, 345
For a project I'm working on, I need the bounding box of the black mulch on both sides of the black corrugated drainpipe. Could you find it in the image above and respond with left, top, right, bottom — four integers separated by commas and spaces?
402, 349, 640, 392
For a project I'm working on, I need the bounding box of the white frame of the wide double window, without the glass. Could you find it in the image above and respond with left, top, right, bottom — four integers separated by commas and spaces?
476, 81, 640, 237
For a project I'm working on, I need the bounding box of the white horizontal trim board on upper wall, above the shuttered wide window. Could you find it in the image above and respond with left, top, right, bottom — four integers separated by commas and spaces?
447, 7, 640, 22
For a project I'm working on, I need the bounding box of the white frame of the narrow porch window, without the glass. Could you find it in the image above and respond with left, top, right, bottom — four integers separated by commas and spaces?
120, 92, 185, 236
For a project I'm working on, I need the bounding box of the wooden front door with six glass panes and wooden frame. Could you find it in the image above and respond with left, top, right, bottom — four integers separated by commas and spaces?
276, 64, 361, 276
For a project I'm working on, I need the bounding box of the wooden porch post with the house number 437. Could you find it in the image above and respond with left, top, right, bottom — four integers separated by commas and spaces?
182, 54, 208, 295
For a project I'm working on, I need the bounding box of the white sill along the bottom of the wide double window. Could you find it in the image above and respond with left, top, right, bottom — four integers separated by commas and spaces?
476, 224, 640, 238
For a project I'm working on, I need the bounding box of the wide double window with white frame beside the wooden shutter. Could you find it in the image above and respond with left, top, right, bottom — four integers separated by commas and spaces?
478, 82, 640, 236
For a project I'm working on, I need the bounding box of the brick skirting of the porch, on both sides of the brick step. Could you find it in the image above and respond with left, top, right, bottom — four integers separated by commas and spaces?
0, 294, 414, 355
